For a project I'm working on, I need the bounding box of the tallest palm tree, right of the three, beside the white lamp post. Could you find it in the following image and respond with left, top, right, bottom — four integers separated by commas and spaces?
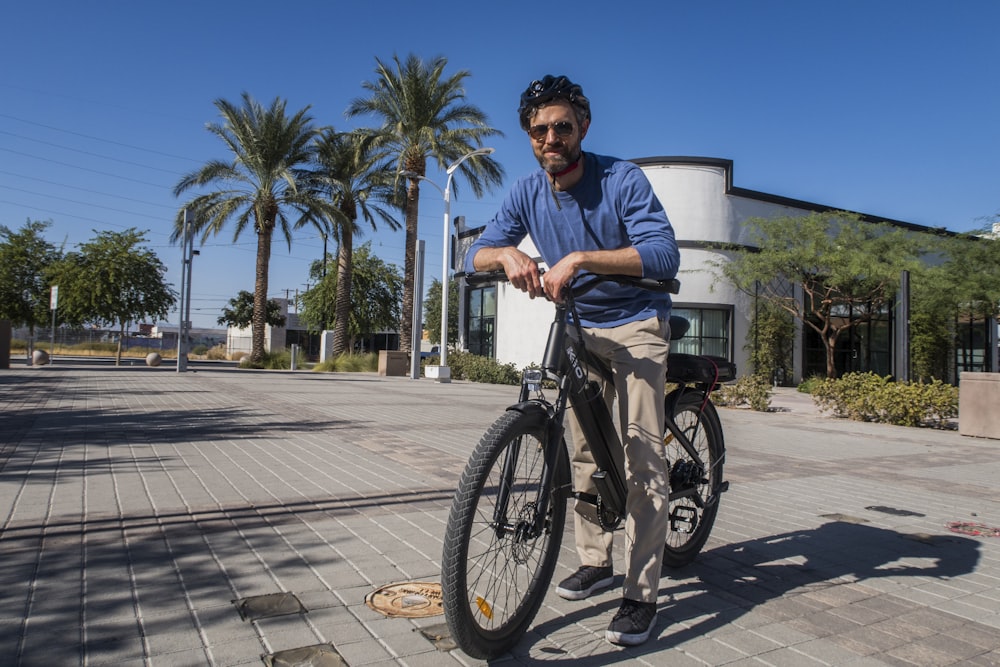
347, 54, 504, 350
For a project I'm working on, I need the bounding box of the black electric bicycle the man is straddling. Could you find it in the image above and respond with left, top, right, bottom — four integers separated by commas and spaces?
441, 272, 736, 659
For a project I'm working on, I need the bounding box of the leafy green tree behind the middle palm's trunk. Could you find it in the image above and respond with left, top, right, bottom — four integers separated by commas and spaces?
299, 243, 403, 350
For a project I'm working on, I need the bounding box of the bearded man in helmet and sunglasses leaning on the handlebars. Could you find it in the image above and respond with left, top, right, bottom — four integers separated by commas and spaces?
465, 76, 679, 645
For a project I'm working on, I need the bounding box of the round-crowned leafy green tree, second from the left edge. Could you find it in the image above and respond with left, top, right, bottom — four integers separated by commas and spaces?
51, 228, 177, 365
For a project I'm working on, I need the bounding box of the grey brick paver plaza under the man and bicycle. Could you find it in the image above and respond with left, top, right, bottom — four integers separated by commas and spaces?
0, 363, 1000, 666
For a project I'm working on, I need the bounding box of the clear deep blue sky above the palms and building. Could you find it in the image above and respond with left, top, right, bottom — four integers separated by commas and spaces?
0, 0, 1000, 326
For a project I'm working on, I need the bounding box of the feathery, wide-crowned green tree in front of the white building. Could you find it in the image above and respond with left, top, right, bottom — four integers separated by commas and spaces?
719, 211, 927, 378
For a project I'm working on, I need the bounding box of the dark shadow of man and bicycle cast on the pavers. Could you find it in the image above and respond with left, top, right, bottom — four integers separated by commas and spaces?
528, 521, 980, 665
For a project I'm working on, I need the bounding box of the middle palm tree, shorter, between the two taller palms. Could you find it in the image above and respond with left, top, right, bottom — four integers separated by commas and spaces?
312, 128, 404, 357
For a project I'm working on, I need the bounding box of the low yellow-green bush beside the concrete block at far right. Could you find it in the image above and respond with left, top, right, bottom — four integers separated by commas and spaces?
812, 373, 958, 428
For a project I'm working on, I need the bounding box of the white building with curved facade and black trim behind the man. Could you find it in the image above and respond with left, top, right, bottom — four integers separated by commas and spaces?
456, 157, 992, 383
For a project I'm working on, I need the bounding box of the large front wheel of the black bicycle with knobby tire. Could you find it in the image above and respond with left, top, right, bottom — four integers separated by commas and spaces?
441, 410, 569, 659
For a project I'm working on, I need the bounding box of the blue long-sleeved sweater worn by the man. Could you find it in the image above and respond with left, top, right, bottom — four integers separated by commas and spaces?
465, 153, 680, 328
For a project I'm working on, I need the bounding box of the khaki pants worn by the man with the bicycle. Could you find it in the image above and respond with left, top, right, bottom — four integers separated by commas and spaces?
566, 317, 670, 602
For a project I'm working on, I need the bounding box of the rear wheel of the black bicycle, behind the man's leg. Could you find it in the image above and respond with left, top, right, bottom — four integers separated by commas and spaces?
663, 392, 726, 568
